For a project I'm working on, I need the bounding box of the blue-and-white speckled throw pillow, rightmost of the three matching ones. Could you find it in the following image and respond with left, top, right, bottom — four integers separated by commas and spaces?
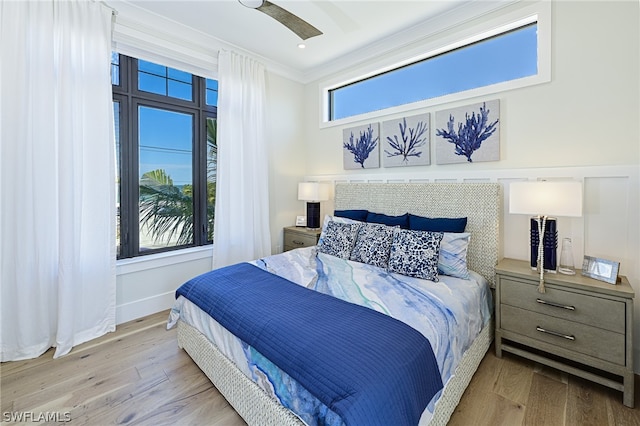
388, 229, 443, 282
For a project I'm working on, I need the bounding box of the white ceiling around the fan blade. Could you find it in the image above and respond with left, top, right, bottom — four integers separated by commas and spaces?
106, 0, 504, 78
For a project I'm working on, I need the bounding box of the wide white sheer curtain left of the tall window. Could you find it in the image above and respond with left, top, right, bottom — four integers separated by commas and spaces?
0, 0, 115, 361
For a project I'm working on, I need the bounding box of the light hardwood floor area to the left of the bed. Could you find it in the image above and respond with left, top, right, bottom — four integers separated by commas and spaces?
0, 311, 245, 426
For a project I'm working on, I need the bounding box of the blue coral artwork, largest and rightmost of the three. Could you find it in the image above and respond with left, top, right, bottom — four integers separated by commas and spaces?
435, 99, 500, 164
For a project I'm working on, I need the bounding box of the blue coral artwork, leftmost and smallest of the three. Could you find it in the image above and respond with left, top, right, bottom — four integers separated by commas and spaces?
342, 123, 380, 170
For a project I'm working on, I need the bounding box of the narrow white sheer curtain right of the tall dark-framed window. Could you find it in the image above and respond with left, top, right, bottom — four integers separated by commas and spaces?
213, 51, 271, 268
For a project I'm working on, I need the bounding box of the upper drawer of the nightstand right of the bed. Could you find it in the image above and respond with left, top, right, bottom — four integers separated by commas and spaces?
500, 279, 625, 334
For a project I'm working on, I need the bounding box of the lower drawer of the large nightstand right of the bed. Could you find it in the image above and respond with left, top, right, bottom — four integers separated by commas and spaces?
500, 305, 625, 365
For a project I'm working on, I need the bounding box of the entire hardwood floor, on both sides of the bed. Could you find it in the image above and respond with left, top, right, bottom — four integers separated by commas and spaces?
0, 312, 640, 426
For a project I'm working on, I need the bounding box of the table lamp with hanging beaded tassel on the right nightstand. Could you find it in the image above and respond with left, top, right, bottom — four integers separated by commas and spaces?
509, 181, 582, 293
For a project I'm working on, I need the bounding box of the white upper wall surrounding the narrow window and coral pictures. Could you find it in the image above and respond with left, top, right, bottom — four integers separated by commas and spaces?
305, 1, 640, 175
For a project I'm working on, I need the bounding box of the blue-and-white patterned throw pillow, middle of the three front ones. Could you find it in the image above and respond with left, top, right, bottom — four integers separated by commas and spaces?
350, 223, 394, 269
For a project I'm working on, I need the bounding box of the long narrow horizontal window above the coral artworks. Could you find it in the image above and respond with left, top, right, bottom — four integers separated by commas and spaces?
327, 20, 539, 121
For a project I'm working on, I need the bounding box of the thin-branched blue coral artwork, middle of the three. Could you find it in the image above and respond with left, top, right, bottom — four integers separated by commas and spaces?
381, 114, 431, 167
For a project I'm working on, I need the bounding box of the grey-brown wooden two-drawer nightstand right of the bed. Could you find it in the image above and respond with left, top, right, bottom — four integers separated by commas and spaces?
495, 259, 634, 408
